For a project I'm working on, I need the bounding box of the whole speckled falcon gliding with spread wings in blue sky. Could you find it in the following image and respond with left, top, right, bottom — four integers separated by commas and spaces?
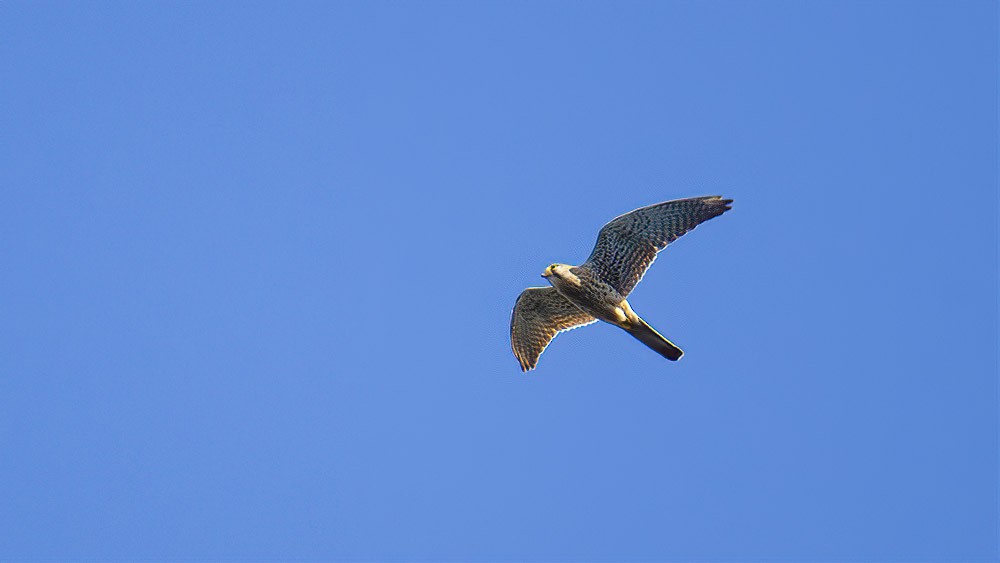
510, 195, 733, 372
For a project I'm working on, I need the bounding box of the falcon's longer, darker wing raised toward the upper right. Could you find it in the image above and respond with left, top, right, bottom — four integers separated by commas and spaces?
583, 196, 733, 296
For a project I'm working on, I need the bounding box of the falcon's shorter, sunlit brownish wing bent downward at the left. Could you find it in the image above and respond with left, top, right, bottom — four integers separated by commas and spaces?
510, 287, 597, 371
